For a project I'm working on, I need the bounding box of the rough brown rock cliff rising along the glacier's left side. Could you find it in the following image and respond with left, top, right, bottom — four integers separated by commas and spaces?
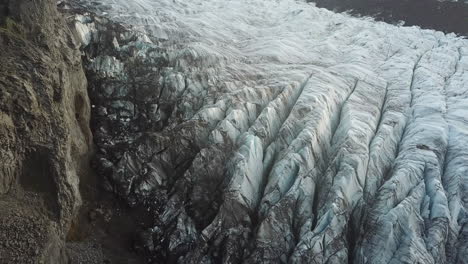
0, 0, 92, 263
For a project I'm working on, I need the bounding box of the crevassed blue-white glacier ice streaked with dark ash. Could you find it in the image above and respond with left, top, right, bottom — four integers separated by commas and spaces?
71, 0, 468, 263
